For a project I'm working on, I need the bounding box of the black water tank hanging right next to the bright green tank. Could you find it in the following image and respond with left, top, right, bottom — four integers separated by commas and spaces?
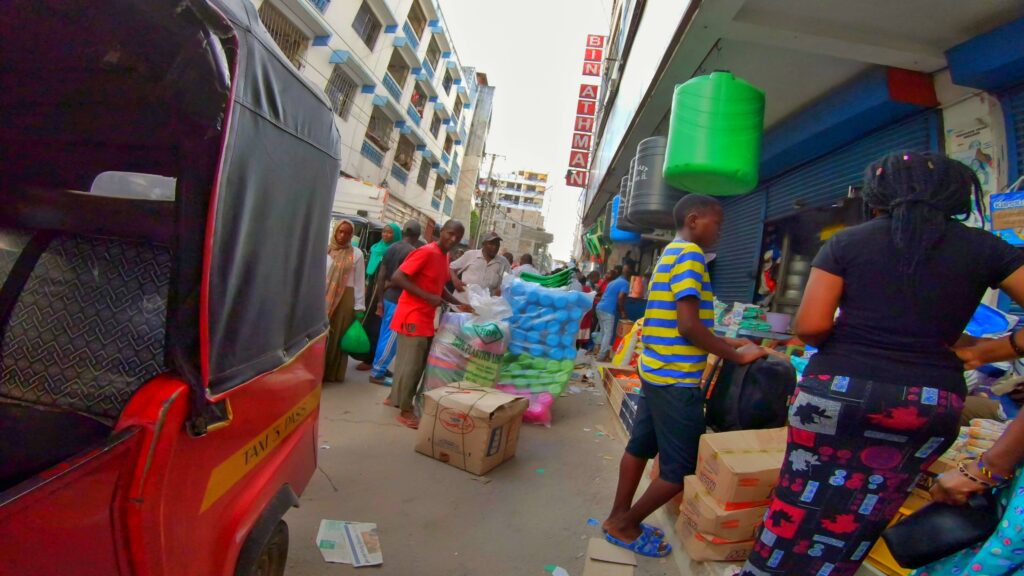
627, 136, 687, 230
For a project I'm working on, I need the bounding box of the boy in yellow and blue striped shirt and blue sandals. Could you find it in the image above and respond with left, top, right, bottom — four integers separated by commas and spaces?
604, 194, 767, 558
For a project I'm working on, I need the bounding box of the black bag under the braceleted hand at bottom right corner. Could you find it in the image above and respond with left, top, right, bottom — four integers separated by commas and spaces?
882, 492, 1002, 569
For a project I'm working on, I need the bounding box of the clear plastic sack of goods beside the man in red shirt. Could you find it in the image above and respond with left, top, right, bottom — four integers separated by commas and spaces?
423, 286, 512, 390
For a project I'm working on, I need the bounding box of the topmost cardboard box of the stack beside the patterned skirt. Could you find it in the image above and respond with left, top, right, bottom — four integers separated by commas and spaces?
697, 427, 785, 510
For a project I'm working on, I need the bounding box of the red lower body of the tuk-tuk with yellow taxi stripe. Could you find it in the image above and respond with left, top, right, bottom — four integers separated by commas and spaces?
0, 337, 326, 576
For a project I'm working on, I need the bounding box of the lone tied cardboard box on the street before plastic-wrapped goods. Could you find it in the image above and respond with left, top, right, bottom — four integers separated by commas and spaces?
416, 382, 529, 476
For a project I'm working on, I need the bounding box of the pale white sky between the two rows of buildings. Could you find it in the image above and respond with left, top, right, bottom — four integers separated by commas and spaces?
438, 0, 613, 260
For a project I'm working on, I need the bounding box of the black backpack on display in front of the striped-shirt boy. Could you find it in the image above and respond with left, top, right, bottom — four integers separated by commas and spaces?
706, 356, 797, 431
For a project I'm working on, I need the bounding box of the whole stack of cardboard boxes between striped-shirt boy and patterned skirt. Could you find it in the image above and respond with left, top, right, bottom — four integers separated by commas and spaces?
676, 428, 785, 562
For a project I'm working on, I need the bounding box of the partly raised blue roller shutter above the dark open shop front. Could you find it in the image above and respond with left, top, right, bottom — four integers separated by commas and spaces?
766, 112, 939, 220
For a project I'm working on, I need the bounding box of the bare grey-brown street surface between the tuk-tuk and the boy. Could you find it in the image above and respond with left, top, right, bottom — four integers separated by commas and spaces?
286, 363, 685, 576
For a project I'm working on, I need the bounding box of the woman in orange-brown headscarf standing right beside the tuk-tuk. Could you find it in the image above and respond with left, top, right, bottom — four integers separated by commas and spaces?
324, 220, 366, 382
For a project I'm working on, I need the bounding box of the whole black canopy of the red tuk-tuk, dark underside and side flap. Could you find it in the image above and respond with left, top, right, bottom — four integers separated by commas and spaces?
0, 0, 341, 401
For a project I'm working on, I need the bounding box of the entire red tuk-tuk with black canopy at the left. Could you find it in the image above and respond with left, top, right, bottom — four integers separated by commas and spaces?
0, 0, 340, 576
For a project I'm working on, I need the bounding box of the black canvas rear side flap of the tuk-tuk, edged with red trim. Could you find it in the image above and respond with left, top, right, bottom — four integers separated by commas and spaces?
199, 0, 341, 396
